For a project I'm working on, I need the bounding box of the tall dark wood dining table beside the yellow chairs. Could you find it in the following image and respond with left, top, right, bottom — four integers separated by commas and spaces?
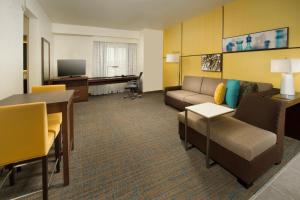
0, 90, 74, 186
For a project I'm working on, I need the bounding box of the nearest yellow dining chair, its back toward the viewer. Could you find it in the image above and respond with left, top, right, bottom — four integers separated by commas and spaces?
0, 102, 60, 199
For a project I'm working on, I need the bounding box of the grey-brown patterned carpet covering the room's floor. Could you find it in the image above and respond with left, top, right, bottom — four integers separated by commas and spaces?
0, 93, 300, 200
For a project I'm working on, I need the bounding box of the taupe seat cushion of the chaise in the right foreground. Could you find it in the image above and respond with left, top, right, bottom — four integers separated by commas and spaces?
178, 112, 276, 161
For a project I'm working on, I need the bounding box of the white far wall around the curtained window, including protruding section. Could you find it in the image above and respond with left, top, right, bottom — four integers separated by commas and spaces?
51, 24, 163, 92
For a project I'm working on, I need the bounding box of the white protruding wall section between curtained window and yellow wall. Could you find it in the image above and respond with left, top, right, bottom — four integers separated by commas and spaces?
142, 29, 163, 92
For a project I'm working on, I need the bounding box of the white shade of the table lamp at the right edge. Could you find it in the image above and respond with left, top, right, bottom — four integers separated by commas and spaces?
271, 59, 300, 74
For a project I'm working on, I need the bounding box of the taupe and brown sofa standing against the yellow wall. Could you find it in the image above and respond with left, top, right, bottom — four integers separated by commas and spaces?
164, 76, 273, 111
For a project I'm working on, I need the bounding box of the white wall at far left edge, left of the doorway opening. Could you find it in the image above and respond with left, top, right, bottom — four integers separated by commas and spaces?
0, 0, 23, 99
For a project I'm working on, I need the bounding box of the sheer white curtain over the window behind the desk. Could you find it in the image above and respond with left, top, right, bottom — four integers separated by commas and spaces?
90, 42, 137, 95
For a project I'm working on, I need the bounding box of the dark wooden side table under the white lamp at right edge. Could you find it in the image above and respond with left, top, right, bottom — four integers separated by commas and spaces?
272, 93, 300, 140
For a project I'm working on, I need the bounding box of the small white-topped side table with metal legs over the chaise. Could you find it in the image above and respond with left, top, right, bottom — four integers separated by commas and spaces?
185, 103, 234, 168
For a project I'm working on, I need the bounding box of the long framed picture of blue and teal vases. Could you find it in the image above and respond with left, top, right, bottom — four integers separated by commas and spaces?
223, 27, 289, 53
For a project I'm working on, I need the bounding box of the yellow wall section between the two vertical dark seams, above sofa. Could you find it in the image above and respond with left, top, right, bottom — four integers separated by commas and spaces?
182, 8, 222, 81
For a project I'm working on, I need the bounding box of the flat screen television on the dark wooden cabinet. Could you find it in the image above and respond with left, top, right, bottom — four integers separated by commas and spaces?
57, 59, 86, 77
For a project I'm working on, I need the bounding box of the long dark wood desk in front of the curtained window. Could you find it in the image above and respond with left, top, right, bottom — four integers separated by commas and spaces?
88, 75, 139, 86
